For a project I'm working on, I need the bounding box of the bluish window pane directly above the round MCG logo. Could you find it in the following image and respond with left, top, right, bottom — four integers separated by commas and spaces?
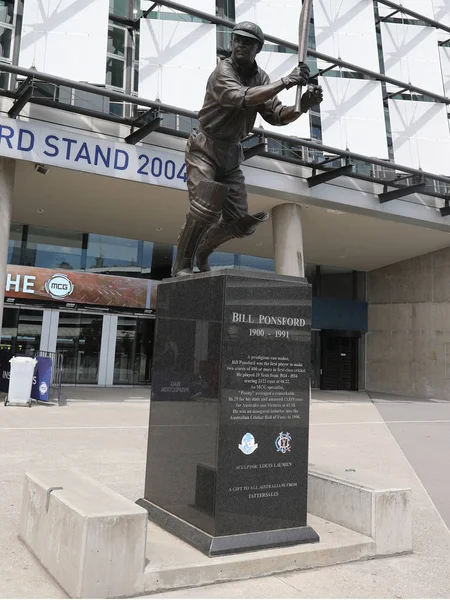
24, 225, 83, 269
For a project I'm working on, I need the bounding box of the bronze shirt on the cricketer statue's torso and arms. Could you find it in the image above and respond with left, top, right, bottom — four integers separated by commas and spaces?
199, 58, 284, 143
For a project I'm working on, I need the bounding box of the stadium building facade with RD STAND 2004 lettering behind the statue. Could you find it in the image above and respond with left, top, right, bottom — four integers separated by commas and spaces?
0, 0, 450, 399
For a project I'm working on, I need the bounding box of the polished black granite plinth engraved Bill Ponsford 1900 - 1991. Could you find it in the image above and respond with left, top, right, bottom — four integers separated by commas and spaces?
138, 270, 318, 555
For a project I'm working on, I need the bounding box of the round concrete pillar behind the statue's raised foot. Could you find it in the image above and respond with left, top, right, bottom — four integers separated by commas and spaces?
272, 204, 305, 277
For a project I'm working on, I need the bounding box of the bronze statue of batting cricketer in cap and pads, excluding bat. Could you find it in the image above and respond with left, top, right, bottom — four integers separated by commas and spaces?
172, 21, 323, 277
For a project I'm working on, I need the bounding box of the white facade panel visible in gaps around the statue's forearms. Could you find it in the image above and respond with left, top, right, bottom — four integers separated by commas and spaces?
256, 52, 311, 139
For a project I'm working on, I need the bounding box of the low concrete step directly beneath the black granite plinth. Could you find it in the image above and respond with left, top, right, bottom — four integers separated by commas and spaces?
144, 515, 376, 594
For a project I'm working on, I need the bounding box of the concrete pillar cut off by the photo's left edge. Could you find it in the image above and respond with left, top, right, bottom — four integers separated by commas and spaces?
0, 158, 16, 330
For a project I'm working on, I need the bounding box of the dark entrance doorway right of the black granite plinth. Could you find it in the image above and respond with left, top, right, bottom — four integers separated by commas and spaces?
320, 330, 360, 391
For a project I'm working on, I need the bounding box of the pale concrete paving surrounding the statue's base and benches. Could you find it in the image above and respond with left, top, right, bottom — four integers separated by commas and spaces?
0, 388, 450, 598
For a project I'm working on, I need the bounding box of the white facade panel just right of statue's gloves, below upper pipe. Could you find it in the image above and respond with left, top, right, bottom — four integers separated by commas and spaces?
320, 77, 388, 158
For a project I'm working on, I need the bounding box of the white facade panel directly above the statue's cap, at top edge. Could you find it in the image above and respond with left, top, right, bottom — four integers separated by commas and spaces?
235, 0, 301, 44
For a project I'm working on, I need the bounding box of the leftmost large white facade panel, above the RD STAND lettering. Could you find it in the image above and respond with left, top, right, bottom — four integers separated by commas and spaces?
19, 0, 109, 84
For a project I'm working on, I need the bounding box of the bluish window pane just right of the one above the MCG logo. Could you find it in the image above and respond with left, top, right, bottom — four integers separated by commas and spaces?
86, 233, 140, 273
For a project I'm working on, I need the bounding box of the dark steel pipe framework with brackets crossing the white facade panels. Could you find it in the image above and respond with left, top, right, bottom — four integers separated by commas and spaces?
0, 0, 450, 216
